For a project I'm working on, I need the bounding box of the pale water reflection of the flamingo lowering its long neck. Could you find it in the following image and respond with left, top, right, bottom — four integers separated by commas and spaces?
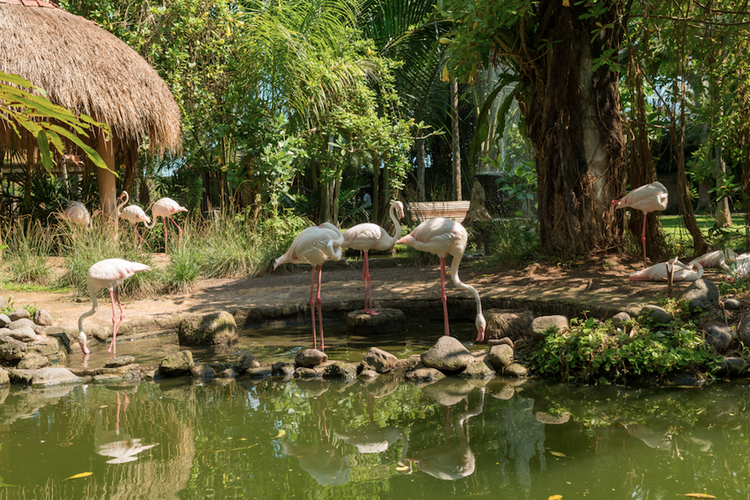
407, 388, 484, 481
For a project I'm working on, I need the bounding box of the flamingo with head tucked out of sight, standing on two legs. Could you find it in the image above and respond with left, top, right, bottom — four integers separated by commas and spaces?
273, 222, 344, 351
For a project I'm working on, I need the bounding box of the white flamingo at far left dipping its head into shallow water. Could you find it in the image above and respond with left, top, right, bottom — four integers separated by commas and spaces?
78, 259, 151, 354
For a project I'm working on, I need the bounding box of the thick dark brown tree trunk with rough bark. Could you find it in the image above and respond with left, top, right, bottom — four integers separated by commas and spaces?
519, 1, 626, 254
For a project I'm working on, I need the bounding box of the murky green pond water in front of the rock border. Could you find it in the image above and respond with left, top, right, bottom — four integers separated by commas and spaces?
0, 322, 750, 500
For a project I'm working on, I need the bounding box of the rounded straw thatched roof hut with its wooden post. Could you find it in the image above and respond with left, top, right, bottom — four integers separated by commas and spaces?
0, 0, 180, 217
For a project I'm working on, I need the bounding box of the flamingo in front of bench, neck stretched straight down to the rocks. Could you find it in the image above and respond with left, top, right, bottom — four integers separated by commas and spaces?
396, 217, 487, 342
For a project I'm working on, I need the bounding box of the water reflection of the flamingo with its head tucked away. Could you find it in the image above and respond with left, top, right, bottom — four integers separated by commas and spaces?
281, 397, 352, 485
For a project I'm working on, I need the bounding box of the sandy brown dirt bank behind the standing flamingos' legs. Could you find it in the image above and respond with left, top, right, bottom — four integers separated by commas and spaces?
0, 255, 736, 331
